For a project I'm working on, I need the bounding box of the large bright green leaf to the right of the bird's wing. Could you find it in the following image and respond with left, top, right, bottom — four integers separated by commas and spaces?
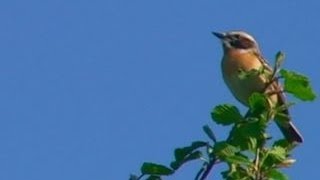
280, 69, 316, 101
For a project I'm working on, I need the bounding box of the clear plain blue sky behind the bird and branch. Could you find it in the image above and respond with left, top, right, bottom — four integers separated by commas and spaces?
0, 0, 320, 180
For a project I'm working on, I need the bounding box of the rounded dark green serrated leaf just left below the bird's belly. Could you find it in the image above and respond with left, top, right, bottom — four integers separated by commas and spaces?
211, 104, 243, 125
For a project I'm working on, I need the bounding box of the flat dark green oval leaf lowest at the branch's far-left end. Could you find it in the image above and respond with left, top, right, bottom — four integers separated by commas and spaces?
141, 162, 174, 175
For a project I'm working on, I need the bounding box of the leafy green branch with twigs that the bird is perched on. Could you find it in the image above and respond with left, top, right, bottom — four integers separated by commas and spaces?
130, 52, 316, 180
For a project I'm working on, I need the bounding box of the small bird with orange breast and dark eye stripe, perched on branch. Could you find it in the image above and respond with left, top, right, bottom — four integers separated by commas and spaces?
212, 31, 303, 143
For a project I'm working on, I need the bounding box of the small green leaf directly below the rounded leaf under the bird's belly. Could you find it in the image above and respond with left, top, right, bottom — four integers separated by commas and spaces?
213, 141, 239, 159
